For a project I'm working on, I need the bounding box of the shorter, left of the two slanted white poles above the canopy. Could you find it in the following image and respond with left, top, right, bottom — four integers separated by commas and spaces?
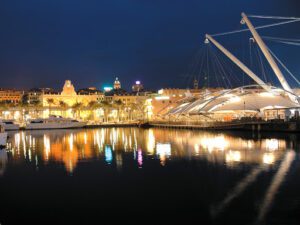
205, 34, 271, 91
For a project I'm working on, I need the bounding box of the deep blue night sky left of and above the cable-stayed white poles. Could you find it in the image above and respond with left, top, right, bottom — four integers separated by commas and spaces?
0, 0, 300, 89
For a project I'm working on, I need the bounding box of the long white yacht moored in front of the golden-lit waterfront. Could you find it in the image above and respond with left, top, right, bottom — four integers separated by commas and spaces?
25, 116, 86, 130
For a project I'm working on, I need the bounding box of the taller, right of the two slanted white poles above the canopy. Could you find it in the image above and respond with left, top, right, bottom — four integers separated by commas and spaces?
242, 13, 299, 103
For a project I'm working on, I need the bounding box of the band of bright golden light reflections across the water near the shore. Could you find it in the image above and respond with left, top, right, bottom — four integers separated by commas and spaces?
1, 128, 287, 173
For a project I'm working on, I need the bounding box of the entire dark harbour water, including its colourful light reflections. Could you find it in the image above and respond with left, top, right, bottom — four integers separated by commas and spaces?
0, 128, 300, 225
